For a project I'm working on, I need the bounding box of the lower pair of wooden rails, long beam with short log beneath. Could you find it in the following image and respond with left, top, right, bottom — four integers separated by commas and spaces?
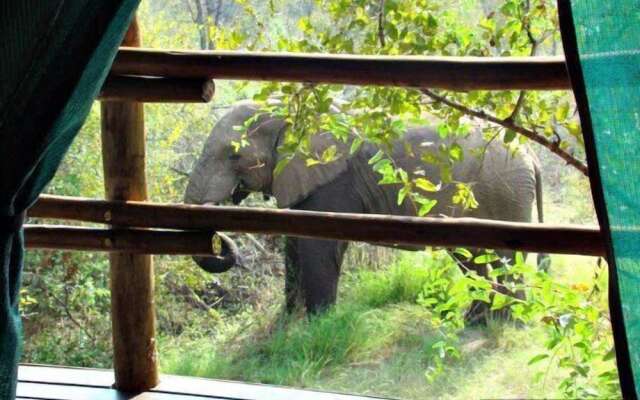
27, 196, 604, 256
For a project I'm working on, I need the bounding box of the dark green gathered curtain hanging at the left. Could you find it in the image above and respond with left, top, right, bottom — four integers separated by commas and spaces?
0, 0, 139, 399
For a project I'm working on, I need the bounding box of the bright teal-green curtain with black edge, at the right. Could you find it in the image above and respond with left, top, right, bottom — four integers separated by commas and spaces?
558, 0, 640, 398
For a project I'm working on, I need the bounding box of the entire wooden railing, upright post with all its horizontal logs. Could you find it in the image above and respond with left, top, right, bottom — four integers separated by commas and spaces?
25, 14, 584, 392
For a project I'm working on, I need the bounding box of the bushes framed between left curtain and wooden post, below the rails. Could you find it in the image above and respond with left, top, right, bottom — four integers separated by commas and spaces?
21, 251, 112, 367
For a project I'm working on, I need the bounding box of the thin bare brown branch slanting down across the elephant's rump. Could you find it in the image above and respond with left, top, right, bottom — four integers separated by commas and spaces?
420, 89, 589, 176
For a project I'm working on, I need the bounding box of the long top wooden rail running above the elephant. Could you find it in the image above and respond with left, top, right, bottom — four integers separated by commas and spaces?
111, 47, 570, 91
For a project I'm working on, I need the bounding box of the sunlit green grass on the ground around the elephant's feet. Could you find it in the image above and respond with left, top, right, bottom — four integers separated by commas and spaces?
160, 253, 608, 399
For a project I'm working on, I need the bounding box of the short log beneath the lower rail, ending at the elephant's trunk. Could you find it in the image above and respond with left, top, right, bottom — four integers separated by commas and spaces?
24, 225, 215, 256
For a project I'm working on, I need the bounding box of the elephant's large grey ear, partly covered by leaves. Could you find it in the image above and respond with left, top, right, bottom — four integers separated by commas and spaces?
271, 133, 349, 208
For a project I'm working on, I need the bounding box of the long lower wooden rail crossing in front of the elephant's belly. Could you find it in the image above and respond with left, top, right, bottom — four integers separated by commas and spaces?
28, 196, 605, 256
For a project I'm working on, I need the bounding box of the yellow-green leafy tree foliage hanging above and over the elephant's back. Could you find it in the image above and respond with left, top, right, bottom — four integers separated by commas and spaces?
248, 0, 582, 215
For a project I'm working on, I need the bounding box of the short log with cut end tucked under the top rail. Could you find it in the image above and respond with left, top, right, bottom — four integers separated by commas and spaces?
98, 75, 215, 103
